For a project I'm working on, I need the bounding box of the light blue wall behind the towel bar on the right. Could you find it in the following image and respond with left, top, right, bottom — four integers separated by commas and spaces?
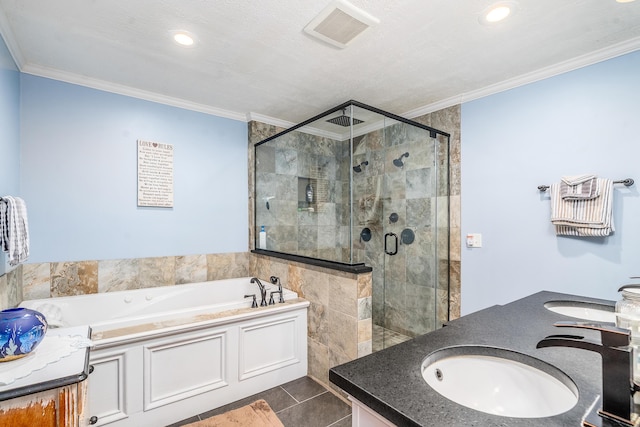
461, 52, 640, 314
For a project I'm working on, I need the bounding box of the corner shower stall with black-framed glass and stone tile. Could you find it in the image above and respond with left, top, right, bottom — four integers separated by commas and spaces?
254, 101, 449, 351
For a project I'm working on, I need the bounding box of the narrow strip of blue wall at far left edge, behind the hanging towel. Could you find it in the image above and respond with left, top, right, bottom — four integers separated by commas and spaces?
0, 37, 20, 275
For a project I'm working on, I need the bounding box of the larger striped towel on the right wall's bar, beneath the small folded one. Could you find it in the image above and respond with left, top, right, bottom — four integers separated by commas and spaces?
550, 178, 615, 237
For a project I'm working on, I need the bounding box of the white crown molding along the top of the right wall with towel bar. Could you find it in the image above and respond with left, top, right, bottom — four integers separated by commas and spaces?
402, 37, 640, 119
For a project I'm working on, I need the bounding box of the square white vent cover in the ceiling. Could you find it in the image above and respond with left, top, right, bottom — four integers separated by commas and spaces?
304, 0, 380, 48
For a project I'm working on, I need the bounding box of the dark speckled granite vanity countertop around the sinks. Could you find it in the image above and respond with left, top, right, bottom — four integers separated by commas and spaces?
329, 291, 615, 427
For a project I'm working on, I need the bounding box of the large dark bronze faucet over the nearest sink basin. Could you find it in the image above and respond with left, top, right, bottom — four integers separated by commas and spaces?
536, 321, 640, 426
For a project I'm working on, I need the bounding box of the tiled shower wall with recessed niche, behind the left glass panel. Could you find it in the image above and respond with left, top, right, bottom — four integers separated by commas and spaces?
254, 131, 350, 262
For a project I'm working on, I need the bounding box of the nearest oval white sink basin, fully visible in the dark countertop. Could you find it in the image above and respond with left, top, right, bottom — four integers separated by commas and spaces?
422, 346, 578, 418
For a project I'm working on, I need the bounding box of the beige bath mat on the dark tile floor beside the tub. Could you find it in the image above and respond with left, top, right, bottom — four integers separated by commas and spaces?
184, 399, 284, 427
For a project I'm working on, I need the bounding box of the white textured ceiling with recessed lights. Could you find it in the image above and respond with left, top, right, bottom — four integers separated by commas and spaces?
0, 0, 640, 123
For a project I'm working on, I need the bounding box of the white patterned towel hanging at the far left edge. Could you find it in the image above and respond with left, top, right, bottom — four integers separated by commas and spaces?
0, 196, 29, 266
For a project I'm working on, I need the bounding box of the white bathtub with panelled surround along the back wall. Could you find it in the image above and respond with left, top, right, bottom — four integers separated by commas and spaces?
20, 277, 309, 427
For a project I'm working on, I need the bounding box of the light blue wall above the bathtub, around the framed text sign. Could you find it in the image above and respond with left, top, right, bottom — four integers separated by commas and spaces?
20, 74, 248, 263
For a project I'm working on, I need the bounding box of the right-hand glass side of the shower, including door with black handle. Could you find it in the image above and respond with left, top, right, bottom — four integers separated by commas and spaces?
352, 109, 449, 351
